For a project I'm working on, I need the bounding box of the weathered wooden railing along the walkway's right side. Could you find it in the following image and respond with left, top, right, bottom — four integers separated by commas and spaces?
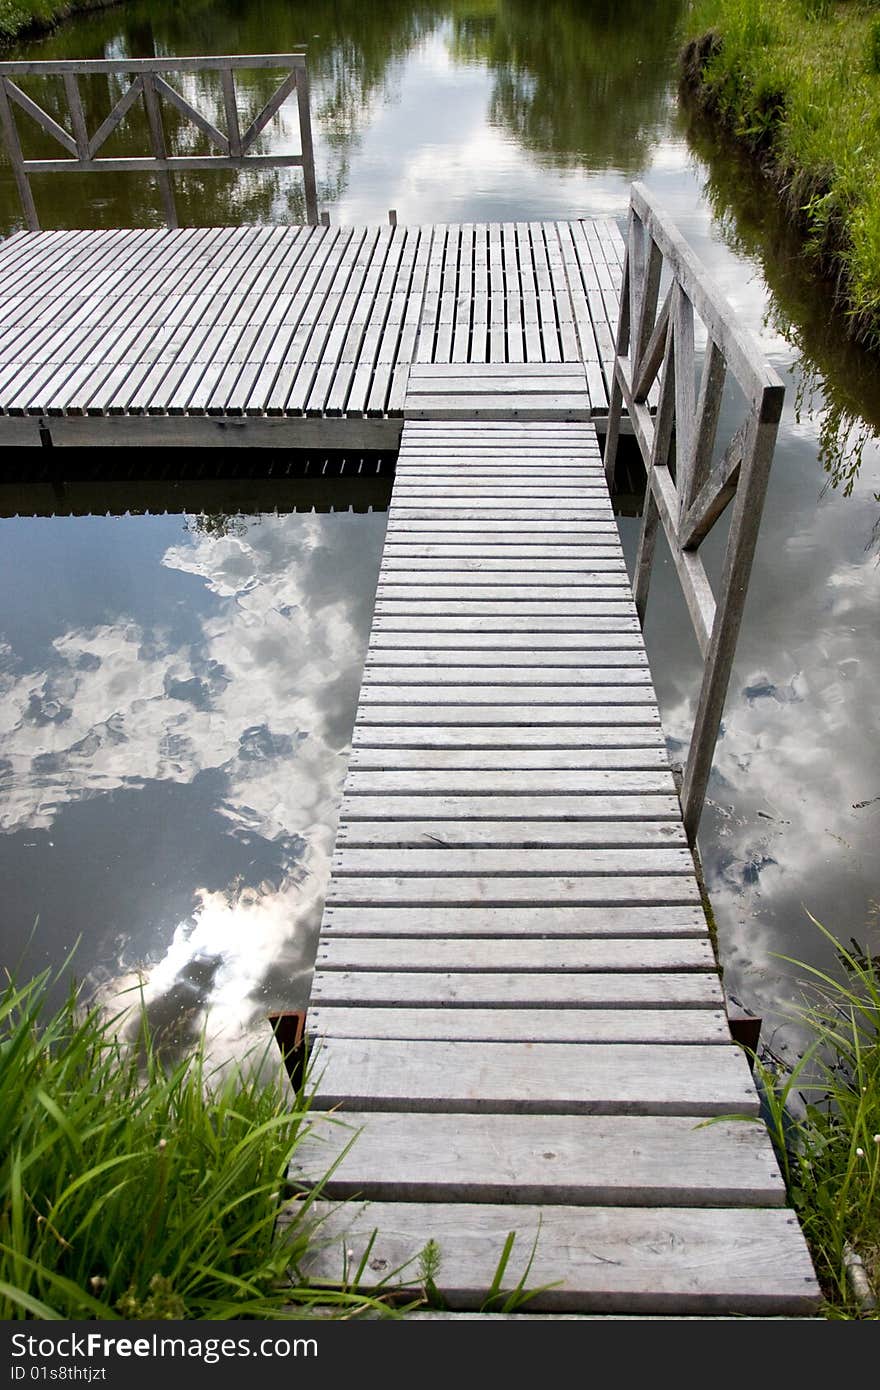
605, 183, 784, 844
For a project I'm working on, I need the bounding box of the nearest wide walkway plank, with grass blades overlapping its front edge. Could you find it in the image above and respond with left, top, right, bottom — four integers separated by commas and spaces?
304, 1200, 819, 1315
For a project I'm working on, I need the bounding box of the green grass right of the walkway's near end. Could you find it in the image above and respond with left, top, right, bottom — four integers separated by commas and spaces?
739, 917, 880, 1319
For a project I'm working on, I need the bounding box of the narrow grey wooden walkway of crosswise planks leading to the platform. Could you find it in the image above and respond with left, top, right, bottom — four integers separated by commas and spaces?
292, 380, 817, 1315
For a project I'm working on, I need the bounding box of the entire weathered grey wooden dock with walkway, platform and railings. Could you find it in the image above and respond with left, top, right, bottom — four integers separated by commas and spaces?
0, 56, 819, 1316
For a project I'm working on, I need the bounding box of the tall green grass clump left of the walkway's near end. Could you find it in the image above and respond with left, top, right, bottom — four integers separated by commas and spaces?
0, 972, 397, 1321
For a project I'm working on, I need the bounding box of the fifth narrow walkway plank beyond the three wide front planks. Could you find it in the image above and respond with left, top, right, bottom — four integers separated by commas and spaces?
327, 872, 699, 908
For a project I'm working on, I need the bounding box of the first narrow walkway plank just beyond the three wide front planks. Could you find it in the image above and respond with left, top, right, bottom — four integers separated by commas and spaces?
307, 1005, 730, 1045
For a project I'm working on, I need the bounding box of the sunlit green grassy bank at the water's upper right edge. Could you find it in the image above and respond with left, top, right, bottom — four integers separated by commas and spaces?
681, 0, 880, 350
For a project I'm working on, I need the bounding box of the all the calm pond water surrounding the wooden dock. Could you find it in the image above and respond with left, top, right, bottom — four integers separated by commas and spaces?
0, 0, 880, 1051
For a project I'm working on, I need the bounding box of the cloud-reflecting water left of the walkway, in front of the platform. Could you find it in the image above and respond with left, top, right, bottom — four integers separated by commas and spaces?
0, 513, 385, 1051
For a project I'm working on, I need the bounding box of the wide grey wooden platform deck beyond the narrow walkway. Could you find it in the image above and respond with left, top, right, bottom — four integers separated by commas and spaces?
0, 220, 623, 448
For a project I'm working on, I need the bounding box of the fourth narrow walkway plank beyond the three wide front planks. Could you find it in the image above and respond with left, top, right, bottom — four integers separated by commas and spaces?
321, 906, 706, 940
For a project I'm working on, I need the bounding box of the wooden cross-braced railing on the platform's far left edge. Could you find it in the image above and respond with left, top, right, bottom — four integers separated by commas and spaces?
0, 53, 318, 232
